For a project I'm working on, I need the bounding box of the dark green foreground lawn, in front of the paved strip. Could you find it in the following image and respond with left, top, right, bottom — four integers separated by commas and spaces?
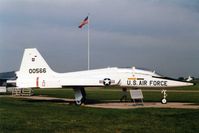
0, 97, 199, 133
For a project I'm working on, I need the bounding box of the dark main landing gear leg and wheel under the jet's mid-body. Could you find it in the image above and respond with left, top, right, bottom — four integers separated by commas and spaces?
73, 87, 86, 105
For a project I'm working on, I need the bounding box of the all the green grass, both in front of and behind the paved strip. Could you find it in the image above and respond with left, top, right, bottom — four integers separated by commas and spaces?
0, 84, 199, 133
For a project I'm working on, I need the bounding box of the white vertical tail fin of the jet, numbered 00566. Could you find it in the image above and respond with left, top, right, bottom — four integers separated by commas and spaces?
20, 48, 54, 75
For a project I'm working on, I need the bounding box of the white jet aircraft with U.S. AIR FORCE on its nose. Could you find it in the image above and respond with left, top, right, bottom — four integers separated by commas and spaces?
8, 48, 193, 105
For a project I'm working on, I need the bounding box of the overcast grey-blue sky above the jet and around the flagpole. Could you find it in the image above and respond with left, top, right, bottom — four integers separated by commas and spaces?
0, 0, 199, 77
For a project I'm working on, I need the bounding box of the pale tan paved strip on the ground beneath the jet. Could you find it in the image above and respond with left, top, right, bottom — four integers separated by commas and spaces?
11, 96, 199, 109
